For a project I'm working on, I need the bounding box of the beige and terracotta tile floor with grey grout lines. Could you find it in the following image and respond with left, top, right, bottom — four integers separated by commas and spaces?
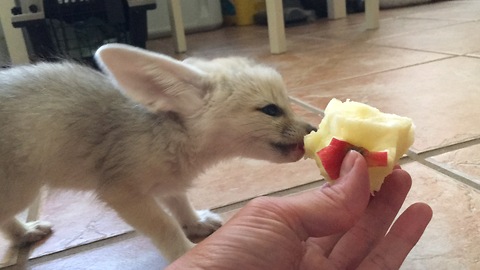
0, 0, 480, 270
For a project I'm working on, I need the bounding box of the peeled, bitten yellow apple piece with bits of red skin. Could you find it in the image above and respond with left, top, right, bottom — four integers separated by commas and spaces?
304, 99, 415, 193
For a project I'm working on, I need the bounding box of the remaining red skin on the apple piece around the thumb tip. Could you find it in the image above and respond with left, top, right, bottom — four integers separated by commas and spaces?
317, 138, 388, 180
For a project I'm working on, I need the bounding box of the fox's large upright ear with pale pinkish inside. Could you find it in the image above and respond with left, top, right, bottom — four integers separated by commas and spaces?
95, 44, 208, 115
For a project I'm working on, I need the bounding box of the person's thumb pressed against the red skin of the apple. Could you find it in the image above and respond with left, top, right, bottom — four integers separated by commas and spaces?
281, 151, 370, 238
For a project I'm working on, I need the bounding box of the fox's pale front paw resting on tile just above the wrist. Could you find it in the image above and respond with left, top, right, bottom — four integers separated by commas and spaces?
182, 210, 222, 243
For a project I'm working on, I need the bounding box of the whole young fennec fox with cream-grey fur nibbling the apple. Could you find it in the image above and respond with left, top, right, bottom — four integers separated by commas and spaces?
0, 44, 313, 261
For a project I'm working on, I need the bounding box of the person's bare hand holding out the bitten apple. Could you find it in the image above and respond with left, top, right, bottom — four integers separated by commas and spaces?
167, 152, 432, 270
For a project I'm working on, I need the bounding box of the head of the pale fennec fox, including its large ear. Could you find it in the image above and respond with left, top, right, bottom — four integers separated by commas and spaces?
95, 44, 314, 163
